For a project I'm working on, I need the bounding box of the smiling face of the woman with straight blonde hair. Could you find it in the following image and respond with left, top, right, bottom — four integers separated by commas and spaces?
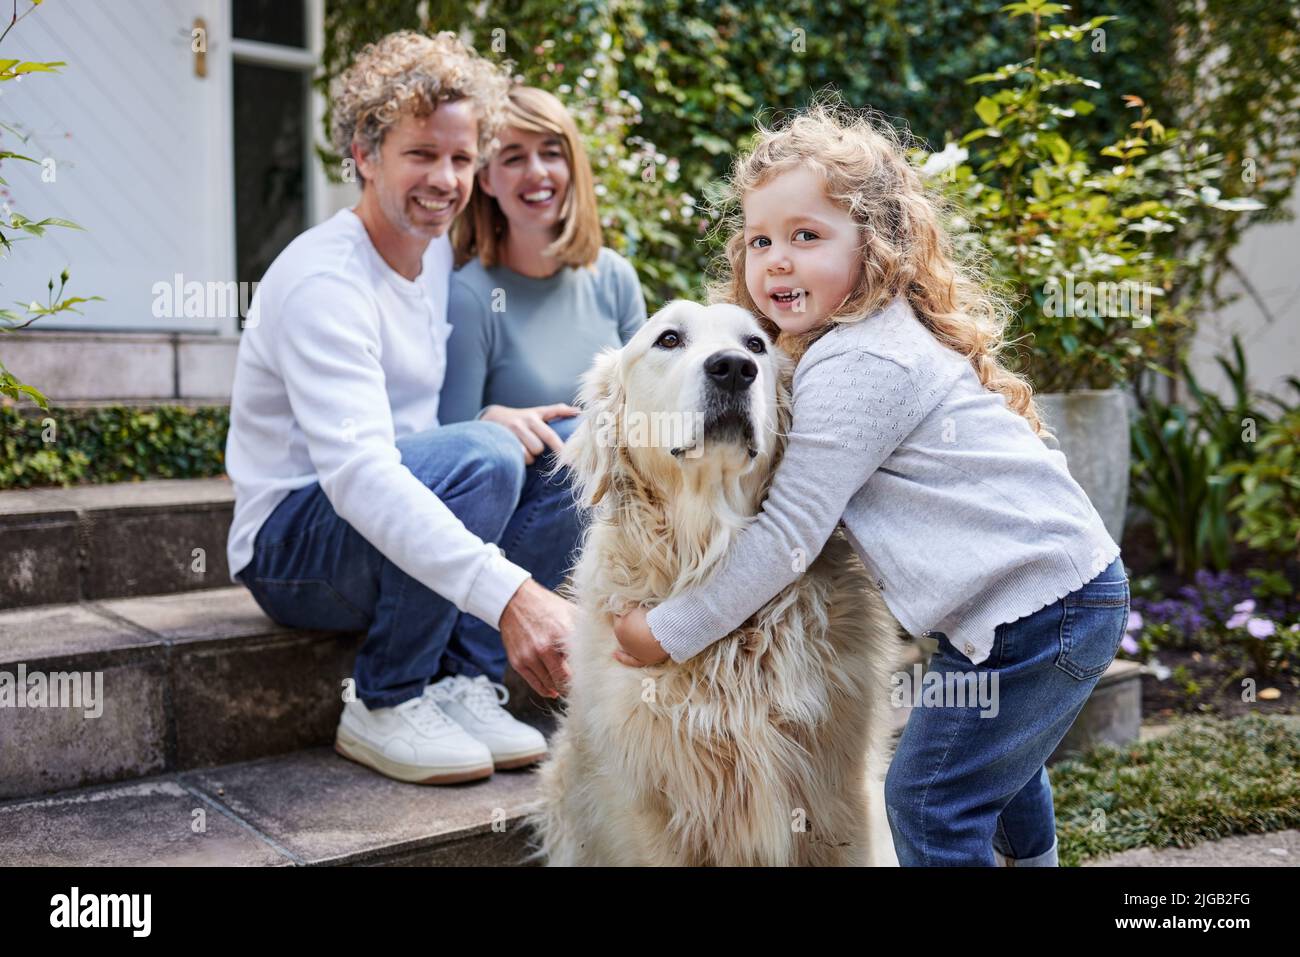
478, 126, 572, 234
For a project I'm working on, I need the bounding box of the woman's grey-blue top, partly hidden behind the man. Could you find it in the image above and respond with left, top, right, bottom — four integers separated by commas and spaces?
438, 248, 646, 424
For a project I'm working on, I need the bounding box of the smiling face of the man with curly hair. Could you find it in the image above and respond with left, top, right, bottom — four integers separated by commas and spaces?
352, 100, 478, 241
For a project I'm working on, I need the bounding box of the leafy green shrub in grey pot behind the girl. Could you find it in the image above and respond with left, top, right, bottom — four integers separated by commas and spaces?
927, 0, 1217, 541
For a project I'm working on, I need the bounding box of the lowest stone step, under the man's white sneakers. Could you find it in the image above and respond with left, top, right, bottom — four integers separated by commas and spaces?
0, 748, 538, 867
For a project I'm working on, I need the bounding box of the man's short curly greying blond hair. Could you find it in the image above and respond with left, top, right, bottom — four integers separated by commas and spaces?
330, 30, 511, 182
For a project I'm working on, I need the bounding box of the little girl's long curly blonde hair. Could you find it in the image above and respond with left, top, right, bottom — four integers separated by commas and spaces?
710, 96, 1050, 436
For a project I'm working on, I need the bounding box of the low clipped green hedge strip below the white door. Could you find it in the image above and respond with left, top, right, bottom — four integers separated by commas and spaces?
0, 404, 230, 489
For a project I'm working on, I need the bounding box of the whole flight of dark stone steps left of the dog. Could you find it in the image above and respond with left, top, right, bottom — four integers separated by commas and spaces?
0, 480, 553, 866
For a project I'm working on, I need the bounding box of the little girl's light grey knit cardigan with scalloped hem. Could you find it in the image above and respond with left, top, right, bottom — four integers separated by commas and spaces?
647, 298, 1119, 664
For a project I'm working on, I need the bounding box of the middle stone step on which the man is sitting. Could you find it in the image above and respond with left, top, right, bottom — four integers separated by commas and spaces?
0, 585, 550, 800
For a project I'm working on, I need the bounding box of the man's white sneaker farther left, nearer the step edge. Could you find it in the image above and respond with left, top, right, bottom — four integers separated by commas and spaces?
334, 694, 493, 784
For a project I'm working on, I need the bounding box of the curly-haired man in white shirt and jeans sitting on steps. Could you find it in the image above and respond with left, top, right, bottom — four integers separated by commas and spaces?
226, 31, 580, 783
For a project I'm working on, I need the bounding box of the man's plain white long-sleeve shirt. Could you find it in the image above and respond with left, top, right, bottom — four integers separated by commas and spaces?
226, 209, 529, 627
